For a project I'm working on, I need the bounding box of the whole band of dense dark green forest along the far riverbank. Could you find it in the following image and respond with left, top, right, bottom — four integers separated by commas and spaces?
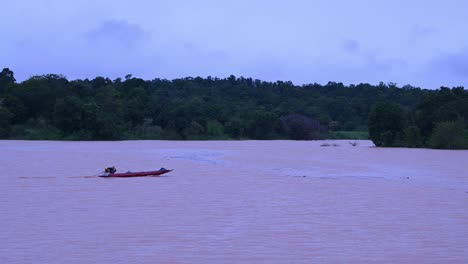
0, 68, 468, 148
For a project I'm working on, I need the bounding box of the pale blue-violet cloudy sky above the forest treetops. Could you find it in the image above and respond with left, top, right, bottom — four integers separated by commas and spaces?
0, 0, 468, 88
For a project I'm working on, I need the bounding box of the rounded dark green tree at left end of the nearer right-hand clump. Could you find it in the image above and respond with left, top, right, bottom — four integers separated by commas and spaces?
369, 102, 406, 147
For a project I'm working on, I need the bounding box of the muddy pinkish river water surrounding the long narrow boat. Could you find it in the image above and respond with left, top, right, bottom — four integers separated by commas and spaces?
0, 141, 468, 263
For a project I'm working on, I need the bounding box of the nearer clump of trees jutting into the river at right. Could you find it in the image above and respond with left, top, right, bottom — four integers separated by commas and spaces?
369, 87, 468, 149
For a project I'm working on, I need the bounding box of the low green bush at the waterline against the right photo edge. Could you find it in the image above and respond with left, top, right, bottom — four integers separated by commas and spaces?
429, 119, 468, 149
